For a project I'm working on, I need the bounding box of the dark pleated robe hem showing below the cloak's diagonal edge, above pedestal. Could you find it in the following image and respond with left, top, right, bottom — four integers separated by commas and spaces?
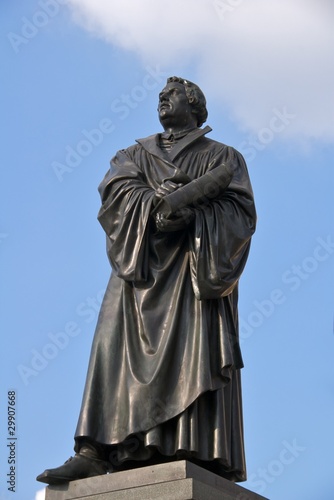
75, 371, 247, 482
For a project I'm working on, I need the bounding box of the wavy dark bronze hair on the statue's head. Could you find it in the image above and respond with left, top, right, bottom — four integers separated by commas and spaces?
160, 76, 208, 127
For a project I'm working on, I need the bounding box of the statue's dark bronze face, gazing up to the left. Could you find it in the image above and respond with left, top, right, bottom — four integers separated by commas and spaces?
158, 82, 196, 129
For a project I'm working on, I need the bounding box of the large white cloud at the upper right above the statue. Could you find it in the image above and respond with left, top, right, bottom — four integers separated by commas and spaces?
68, 0, 334, 140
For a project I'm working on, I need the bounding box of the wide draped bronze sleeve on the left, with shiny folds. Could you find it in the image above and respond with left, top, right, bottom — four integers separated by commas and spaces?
98, 150, 155, 282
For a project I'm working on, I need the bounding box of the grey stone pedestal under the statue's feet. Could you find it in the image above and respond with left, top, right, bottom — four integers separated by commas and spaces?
45, 460, 266, 500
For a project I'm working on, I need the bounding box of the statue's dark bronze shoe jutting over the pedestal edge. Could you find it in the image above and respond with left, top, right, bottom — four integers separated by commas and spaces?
36, 453, 110, 484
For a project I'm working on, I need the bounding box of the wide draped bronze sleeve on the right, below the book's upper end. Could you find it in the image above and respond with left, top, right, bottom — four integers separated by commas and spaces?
189, 148, 256, 300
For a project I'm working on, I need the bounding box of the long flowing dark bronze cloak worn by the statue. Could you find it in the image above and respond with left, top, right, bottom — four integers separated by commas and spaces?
75, 127, 256, 481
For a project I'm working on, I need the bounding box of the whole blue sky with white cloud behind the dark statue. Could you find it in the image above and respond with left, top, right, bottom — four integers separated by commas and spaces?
0, 0, 334, 500
